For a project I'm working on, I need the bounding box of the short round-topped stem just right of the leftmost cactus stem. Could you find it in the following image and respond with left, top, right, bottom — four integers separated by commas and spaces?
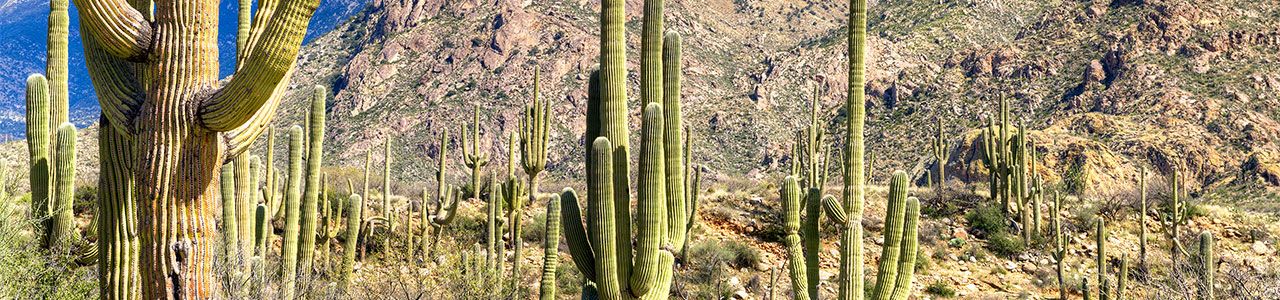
47, 123, 76, 250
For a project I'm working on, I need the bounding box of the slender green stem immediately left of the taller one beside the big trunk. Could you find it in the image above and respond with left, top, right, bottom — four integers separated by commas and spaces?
280, 126, 303, 299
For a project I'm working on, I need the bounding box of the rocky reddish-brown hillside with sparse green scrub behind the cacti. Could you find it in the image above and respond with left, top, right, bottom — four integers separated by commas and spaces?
252, 0, 1280, 201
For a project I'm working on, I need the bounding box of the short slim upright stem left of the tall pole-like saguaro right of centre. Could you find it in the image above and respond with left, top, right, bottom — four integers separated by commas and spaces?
781, 176, 817, 300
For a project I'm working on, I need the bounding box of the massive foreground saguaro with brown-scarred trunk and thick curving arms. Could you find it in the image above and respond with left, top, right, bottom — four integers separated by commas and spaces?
70, 0, 319, 293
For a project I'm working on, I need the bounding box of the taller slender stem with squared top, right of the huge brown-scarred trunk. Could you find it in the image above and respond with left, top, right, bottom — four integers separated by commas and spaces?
298, 86, 328, 274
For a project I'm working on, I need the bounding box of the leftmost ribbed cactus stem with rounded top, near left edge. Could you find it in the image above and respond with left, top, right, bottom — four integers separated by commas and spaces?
27, 74, 52, 247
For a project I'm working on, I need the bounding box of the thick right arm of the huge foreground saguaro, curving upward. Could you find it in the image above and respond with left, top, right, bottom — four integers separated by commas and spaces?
200, 0, 319, 131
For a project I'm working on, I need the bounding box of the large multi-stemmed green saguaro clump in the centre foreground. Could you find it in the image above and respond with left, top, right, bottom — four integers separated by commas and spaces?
561, 0, 691, 299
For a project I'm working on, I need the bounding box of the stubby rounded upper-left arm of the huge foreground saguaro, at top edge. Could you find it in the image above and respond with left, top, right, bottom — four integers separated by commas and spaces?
70, 0, 154, 60
